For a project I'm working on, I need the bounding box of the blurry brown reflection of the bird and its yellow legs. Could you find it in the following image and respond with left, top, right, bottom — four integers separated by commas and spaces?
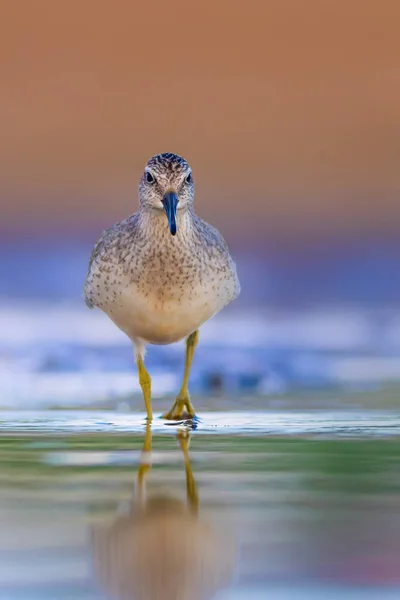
92, 425, 234, 600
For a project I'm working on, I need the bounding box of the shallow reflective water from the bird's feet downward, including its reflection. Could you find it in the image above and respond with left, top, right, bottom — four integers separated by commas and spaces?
0, 410, 400, 600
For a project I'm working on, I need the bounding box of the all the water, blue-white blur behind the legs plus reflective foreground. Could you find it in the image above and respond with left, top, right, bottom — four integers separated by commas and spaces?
0, 303, 400, 600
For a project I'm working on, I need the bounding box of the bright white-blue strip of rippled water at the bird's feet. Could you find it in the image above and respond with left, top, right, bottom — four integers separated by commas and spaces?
0, 410, 400, 437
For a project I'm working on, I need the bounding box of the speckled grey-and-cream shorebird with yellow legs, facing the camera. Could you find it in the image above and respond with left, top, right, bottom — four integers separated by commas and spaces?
83, 152, 241, 422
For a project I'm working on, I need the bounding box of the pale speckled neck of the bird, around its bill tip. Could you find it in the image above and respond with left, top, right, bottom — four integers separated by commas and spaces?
138, 207, 194, 239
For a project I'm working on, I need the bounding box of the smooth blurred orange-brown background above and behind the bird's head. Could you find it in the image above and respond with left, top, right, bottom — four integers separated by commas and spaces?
0, 0, 400, 239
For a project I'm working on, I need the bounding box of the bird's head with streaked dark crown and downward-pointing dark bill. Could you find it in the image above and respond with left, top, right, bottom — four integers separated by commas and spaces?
139, 152, 194, 235
